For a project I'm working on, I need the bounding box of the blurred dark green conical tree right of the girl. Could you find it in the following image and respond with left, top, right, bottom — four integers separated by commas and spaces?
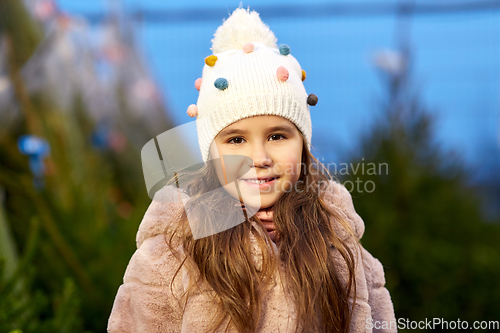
337, 49, 500, 325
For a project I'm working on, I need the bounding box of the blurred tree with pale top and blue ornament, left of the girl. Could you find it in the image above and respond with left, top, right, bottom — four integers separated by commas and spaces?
0, 0, 179, 333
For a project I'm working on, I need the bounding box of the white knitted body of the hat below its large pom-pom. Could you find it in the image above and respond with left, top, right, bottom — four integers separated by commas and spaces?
197, 43, 312, 161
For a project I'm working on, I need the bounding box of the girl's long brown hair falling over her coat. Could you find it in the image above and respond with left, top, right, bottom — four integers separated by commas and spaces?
167, 134, 358, 332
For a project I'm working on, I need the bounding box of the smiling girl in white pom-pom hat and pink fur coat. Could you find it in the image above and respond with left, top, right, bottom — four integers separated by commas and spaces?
108, 8, 396, 333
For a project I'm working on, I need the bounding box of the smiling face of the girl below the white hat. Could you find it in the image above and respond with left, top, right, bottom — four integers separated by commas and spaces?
210, 116, 303, 208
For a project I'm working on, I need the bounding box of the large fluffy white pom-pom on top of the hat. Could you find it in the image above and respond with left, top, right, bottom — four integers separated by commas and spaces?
212, 8, 277, 54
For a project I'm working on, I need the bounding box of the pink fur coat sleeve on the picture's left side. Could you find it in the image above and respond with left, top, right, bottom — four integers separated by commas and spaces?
107, 198, 188, 333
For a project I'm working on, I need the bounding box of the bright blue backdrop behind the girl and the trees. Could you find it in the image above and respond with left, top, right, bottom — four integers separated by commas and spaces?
58, 0, 500, 176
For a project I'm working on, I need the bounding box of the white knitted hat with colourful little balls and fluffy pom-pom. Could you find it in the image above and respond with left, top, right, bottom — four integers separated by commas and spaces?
187, 8, 317, 162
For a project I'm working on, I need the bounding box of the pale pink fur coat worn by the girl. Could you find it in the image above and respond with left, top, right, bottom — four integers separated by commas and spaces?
107, 181, 396, 333
